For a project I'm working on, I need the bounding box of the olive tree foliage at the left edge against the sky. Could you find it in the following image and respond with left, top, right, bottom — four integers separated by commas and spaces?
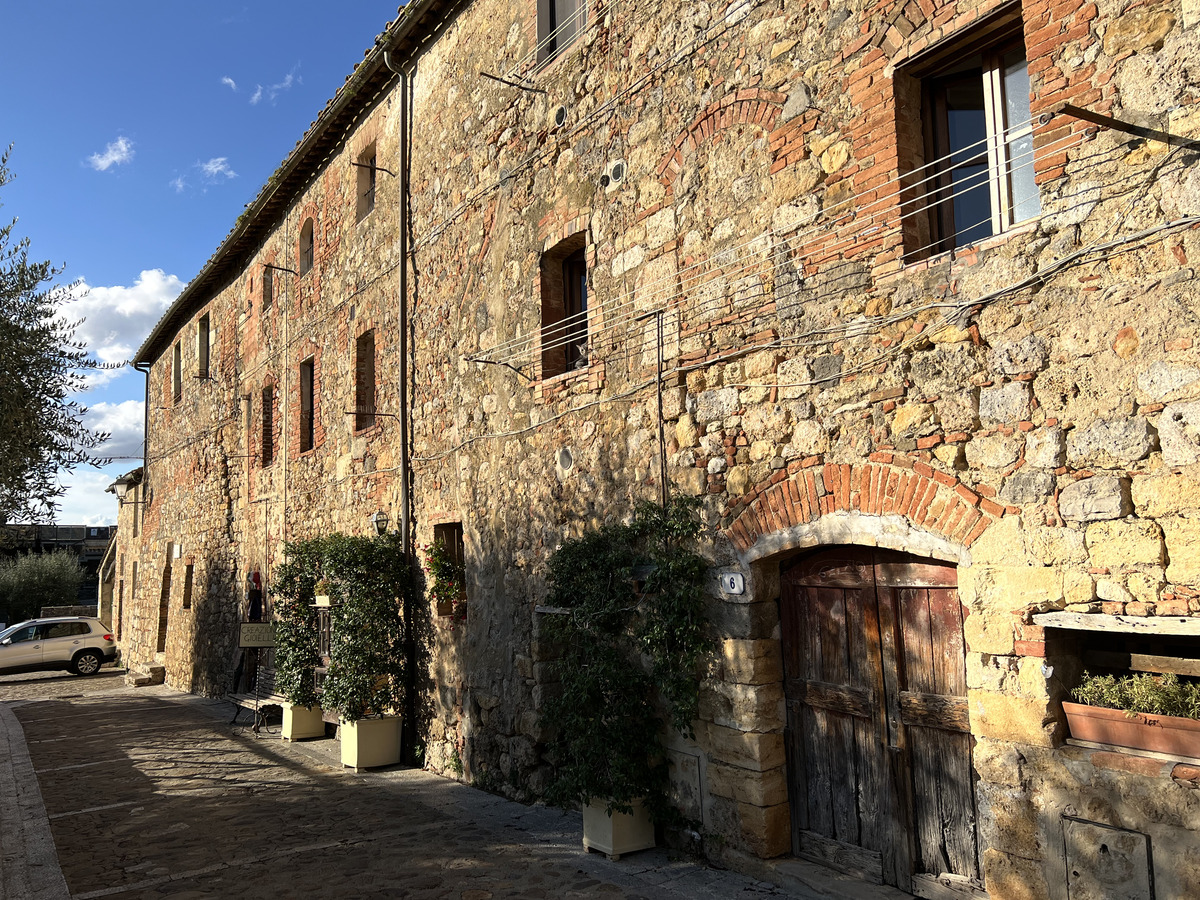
0, 151, 108, 523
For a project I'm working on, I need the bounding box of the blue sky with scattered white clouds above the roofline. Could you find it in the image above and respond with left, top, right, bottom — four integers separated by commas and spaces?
0, 0, 397, 524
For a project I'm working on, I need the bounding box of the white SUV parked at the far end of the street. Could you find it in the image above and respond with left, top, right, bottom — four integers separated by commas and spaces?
0, 616, 116, 674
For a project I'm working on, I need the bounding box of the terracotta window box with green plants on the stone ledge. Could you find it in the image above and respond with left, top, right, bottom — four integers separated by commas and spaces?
1062, 672, 1200, 757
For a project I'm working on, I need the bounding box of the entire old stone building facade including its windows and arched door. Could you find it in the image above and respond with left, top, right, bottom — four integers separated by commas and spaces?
116, 0, 1200, 900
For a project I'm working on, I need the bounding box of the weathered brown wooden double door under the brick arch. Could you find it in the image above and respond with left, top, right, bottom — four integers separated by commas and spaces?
780, 547, 986, 898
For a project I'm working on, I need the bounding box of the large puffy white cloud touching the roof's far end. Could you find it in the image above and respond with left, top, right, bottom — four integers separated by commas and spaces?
60, 269, 184, 388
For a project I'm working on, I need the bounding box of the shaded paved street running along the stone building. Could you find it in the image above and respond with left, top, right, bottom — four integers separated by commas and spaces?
0, 670, 892, 900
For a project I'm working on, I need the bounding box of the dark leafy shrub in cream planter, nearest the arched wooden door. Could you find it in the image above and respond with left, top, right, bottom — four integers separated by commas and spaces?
539, 498, 709, 858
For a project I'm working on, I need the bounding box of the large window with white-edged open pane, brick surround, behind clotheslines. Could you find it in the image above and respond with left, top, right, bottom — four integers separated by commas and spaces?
896, 6, 1042, 262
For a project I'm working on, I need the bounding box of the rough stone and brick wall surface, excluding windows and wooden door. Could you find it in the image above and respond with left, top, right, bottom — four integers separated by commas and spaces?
108, 0, 1200, 899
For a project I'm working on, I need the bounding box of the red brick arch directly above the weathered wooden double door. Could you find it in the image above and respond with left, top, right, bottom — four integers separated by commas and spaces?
726, 452, 1019, 557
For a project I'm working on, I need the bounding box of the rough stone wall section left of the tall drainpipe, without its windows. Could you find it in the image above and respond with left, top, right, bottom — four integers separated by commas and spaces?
120, 98, 408, 695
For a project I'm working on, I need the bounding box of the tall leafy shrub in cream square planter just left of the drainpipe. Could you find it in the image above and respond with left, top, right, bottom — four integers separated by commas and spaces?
322, 534, 412, 769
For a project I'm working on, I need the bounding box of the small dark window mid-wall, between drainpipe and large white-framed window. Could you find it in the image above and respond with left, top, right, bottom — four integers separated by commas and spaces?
541, 232, 588, 378
